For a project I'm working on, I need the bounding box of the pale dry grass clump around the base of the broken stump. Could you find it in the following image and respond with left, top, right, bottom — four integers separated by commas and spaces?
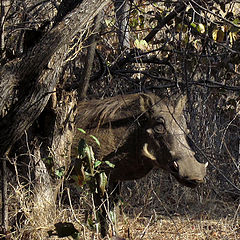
9, 182, 88, 240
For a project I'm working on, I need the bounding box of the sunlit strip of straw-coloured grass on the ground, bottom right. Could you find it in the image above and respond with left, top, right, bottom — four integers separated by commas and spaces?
116, 215, 240, 240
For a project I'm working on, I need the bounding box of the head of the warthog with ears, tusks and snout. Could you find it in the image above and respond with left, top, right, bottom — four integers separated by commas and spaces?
141, 94, 208, 187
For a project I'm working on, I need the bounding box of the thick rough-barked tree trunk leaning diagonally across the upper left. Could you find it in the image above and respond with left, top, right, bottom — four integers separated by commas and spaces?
0, 0, 110, 156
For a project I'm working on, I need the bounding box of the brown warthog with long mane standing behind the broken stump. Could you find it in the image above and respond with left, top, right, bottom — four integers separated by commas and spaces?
72, 93, 207, 235
